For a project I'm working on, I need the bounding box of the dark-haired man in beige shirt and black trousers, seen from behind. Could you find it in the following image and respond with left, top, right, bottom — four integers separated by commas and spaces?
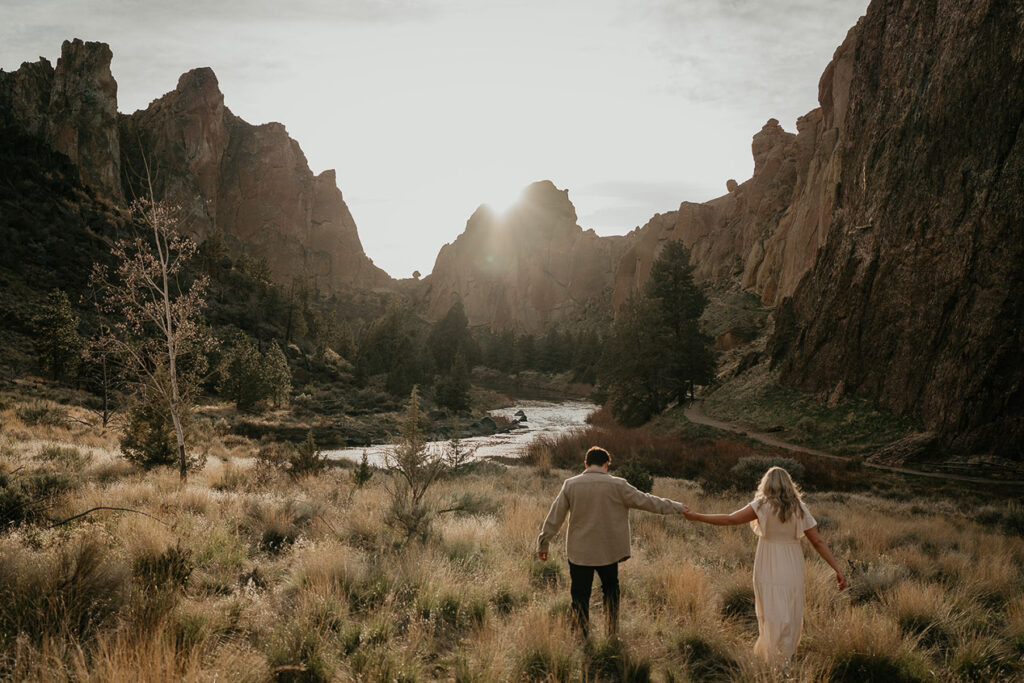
537, 445, 687, 638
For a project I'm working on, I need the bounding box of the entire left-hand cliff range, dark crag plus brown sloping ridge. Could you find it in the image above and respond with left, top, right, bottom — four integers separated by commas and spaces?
0, 40, 392, 291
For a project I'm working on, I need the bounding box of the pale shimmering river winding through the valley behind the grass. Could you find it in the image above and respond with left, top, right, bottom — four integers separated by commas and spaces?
325, 400, 598, 467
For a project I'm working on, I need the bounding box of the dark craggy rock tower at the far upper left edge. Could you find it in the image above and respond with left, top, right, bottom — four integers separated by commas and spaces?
0, 39, 122, 201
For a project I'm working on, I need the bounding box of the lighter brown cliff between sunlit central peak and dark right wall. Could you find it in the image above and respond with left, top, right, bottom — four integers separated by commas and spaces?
613, 27, 859, 310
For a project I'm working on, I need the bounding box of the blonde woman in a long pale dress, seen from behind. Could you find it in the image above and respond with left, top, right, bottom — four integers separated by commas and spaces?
684, 467, 846, 660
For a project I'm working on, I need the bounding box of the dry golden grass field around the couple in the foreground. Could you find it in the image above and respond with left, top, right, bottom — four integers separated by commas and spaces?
0, 401, 1024, 681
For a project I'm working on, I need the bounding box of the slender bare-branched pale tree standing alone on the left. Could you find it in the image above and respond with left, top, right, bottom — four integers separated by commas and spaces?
91, 174, 209, 479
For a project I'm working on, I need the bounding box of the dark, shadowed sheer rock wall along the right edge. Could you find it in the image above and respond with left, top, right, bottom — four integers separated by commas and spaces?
773, 0, 1024, 458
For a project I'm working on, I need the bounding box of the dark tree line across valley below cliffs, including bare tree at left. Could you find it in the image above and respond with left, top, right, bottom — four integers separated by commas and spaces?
24, 202, 714, 476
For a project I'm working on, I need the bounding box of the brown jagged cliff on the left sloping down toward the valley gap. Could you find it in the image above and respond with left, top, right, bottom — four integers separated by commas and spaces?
121, 69, 391, 291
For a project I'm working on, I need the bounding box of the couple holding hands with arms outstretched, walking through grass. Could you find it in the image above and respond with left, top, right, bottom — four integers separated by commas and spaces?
537, 446, 846, 660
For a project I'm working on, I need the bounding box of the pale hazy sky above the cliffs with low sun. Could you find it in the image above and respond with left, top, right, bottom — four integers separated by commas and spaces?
0, 0, 867, 278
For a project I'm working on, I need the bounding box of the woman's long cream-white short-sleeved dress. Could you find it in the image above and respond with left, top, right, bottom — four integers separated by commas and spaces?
751, 501, 817, 659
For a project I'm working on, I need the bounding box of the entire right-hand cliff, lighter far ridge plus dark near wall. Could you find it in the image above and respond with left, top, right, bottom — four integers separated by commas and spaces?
613, 0, 1024, 458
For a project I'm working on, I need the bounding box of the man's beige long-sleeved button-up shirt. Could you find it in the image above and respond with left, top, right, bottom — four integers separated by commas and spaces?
537, 468, 683, 566
